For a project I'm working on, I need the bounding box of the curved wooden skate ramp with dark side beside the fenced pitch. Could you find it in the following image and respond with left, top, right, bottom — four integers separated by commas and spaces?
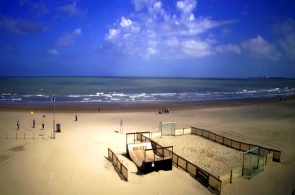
127, 142, 172, 173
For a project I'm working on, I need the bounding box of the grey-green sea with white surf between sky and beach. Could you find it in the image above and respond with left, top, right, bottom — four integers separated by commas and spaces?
0, 77, 295, 105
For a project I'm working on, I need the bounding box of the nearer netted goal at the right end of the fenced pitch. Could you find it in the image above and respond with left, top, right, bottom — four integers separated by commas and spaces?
242, 147, 264, 179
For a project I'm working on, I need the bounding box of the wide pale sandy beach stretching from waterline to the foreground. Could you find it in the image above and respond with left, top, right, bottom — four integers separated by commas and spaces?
0, 98, 295, 194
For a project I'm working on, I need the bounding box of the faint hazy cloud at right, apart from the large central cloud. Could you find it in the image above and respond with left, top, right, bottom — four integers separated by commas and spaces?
242, 35, 281, 60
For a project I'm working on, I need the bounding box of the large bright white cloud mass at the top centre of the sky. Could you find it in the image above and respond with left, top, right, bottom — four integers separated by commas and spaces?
105, 0, 239, 59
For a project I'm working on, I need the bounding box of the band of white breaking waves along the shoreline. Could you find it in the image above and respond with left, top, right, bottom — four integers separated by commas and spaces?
0, 86, 295, 104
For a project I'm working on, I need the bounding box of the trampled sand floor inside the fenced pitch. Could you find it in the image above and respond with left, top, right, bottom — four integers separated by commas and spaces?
154, 135, 243, 177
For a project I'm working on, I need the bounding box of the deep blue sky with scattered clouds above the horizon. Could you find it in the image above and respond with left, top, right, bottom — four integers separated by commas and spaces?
0, 0, 295, 78
